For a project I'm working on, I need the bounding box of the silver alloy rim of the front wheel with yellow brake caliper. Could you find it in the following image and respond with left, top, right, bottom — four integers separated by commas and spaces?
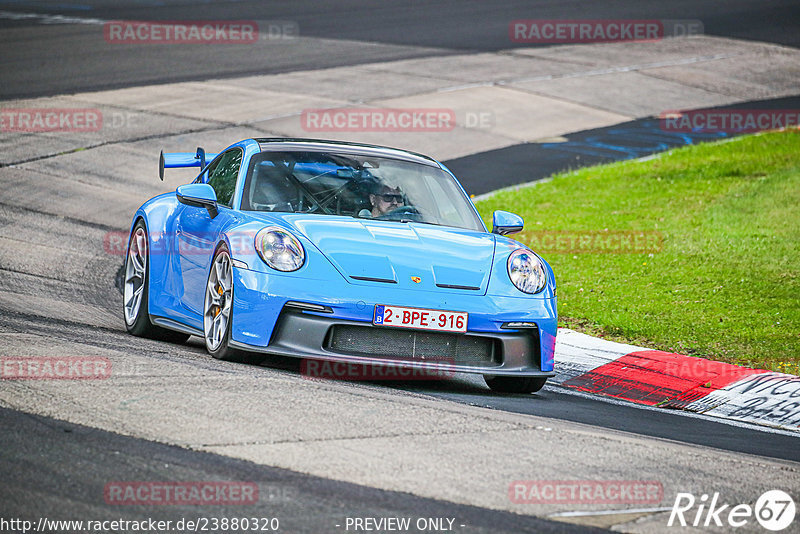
203, 250, 233, 352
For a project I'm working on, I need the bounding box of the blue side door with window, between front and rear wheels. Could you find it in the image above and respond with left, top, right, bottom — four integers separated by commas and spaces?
176, 148, 243, 320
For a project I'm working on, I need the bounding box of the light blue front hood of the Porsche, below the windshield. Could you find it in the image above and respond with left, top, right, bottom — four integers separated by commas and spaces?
272, 214, 495, 293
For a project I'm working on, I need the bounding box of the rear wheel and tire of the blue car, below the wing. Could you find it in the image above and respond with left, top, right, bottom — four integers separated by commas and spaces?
122, 219, 189, 343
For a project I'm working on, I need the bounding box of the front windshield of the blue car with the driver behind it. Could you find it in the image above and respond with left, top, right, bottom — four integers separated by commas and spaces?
241, 151, 484, 231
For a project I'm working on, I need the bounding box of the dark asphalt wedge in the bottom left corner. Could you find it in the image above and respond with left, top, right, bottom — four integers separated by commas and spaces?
0, 408, 596, 534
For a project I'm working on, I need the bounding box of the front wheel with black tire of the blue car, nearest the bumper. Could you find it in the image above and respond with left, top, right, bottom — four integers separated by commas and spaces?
203, 243, 264, 364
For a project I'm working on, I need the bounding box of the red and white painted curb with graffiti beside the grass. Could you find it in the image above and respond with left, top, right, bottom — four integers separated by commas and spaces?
550, 328, 800, 431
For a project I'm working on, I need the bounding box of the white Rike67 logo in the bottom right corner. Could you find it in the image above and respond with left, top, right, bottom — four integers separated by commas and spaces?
667, 490, 795, 532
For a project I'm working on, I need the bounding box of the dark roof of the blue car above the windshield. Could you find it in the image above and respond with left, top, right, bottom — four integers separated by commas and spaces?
254, 137, 441, 168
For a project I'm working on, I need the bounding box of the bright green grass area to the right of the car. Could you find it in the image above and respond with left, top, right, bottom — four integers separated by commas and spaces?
477, 132, 800, 374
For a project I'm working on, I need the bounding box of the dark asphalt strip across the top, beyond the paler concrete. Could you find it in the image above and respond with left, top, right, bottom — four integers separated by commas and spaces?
0, 0, 800, 98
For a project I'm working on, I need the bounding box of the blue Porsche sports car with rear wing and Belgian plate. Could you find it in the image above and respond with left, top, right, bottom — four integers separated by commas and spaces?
123, 138, 556, 393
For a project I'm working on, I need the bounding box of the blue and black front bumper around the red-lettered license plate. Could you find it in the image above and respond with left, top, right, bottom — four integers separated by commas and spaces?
231, 268, 556, 377
